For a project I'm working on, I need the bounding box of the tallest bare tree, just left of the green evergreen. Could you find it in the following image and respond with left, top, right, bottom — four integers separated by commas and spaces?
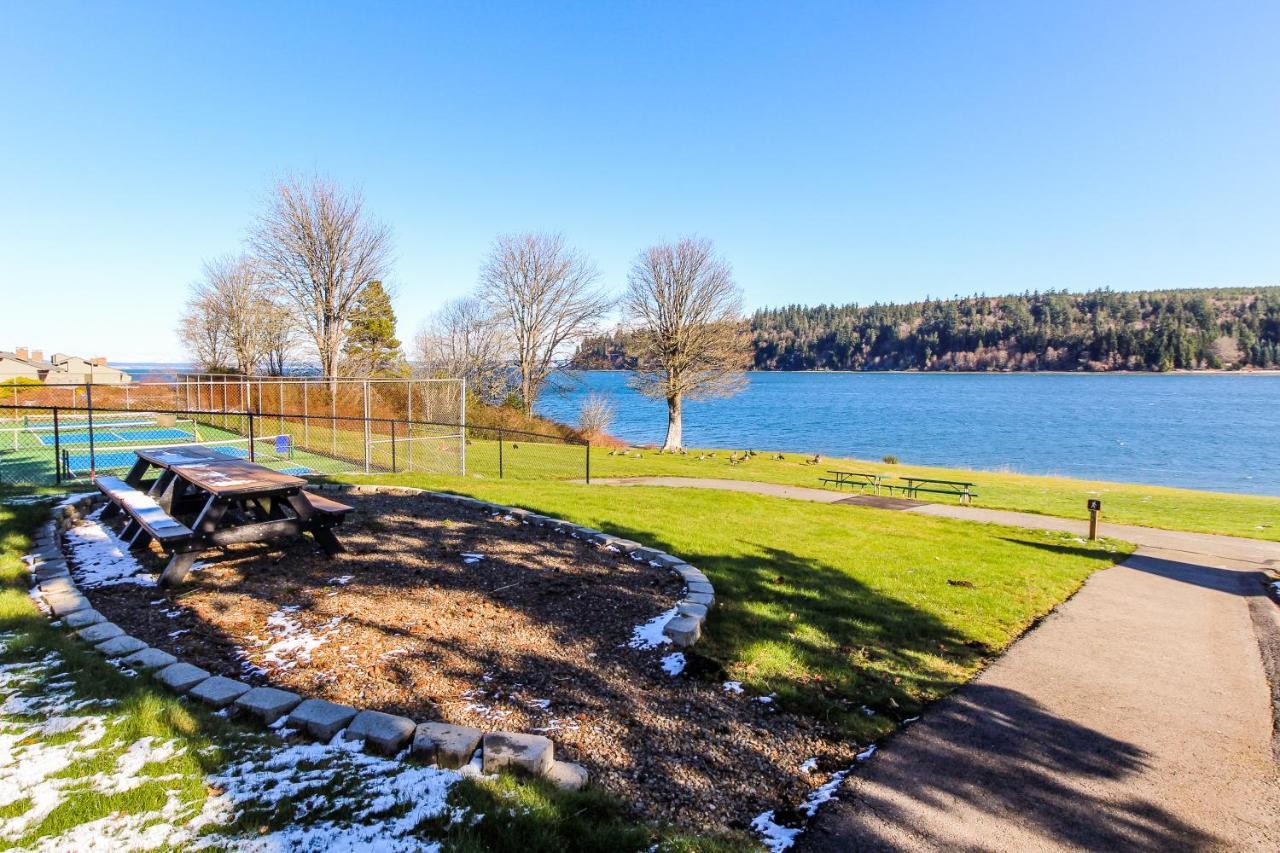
251, 175, 392, 377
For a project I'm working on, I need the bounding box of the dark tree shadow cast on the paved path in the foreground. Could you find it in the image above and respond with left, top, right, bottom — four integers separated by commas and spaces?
796, 684, 1221, 852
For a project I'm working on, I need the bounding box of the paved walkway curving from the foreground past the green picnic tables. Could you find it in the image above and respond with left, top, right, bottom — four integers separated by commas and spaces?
591, 478, 1280, 852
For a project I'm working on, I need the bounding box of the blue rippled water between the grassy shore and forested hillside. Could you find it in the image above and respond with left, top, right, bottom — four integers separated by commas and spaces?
538, 371, 1280, 494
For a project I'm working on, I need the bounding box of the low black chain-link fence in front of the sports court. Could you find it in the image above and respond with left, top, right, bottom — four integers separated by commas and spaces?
0, 403, 591, 487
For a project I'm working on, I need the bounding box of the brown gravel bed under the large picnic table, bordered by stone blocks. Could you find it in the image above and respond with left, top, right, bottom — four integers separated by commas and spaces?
74, 494, 856, 830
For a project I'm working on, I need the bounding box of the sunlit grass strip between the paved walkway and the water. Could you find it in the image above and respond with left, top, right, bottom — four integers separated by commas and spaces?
591, 448, 1280, 542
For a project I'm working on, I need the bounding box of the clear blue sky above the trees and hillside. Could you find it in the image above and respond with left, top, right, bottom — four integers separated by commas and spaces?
0, 1, 1280, 360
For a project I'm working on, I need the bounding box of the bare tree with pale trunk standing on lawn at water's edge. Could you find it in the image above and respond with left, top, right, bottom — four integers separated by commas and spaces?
623, 237, 751, 450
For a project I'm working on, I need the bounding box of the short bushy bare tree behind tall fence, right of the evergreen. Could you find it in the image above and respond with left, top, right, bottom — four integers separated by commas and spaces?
415, 297, 512, 403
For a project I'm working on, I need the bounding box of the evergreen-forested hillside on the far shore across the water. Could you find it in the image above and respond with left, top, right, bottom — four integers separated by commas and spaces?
573, 287, 1280, 370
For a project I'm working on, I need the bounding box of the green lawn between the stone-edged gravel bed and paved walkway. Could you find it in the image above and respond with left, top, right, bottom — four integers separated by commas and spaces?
330, 475, 1129, 740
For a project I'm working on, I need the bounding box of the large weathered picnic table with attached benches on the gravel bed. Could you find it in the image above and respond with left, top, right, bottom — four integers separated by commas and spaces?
95, 446, 352, 587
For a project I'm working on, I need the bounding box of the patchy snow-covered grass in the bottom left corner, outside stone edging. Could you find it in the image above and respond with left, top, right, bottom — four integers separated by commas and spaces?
0, 634, 480, 853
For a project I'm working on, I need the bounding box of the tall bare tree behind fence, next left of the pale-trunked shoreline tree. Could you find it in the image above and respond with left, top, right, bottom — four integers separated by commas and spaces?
479, 233, 612, 411
